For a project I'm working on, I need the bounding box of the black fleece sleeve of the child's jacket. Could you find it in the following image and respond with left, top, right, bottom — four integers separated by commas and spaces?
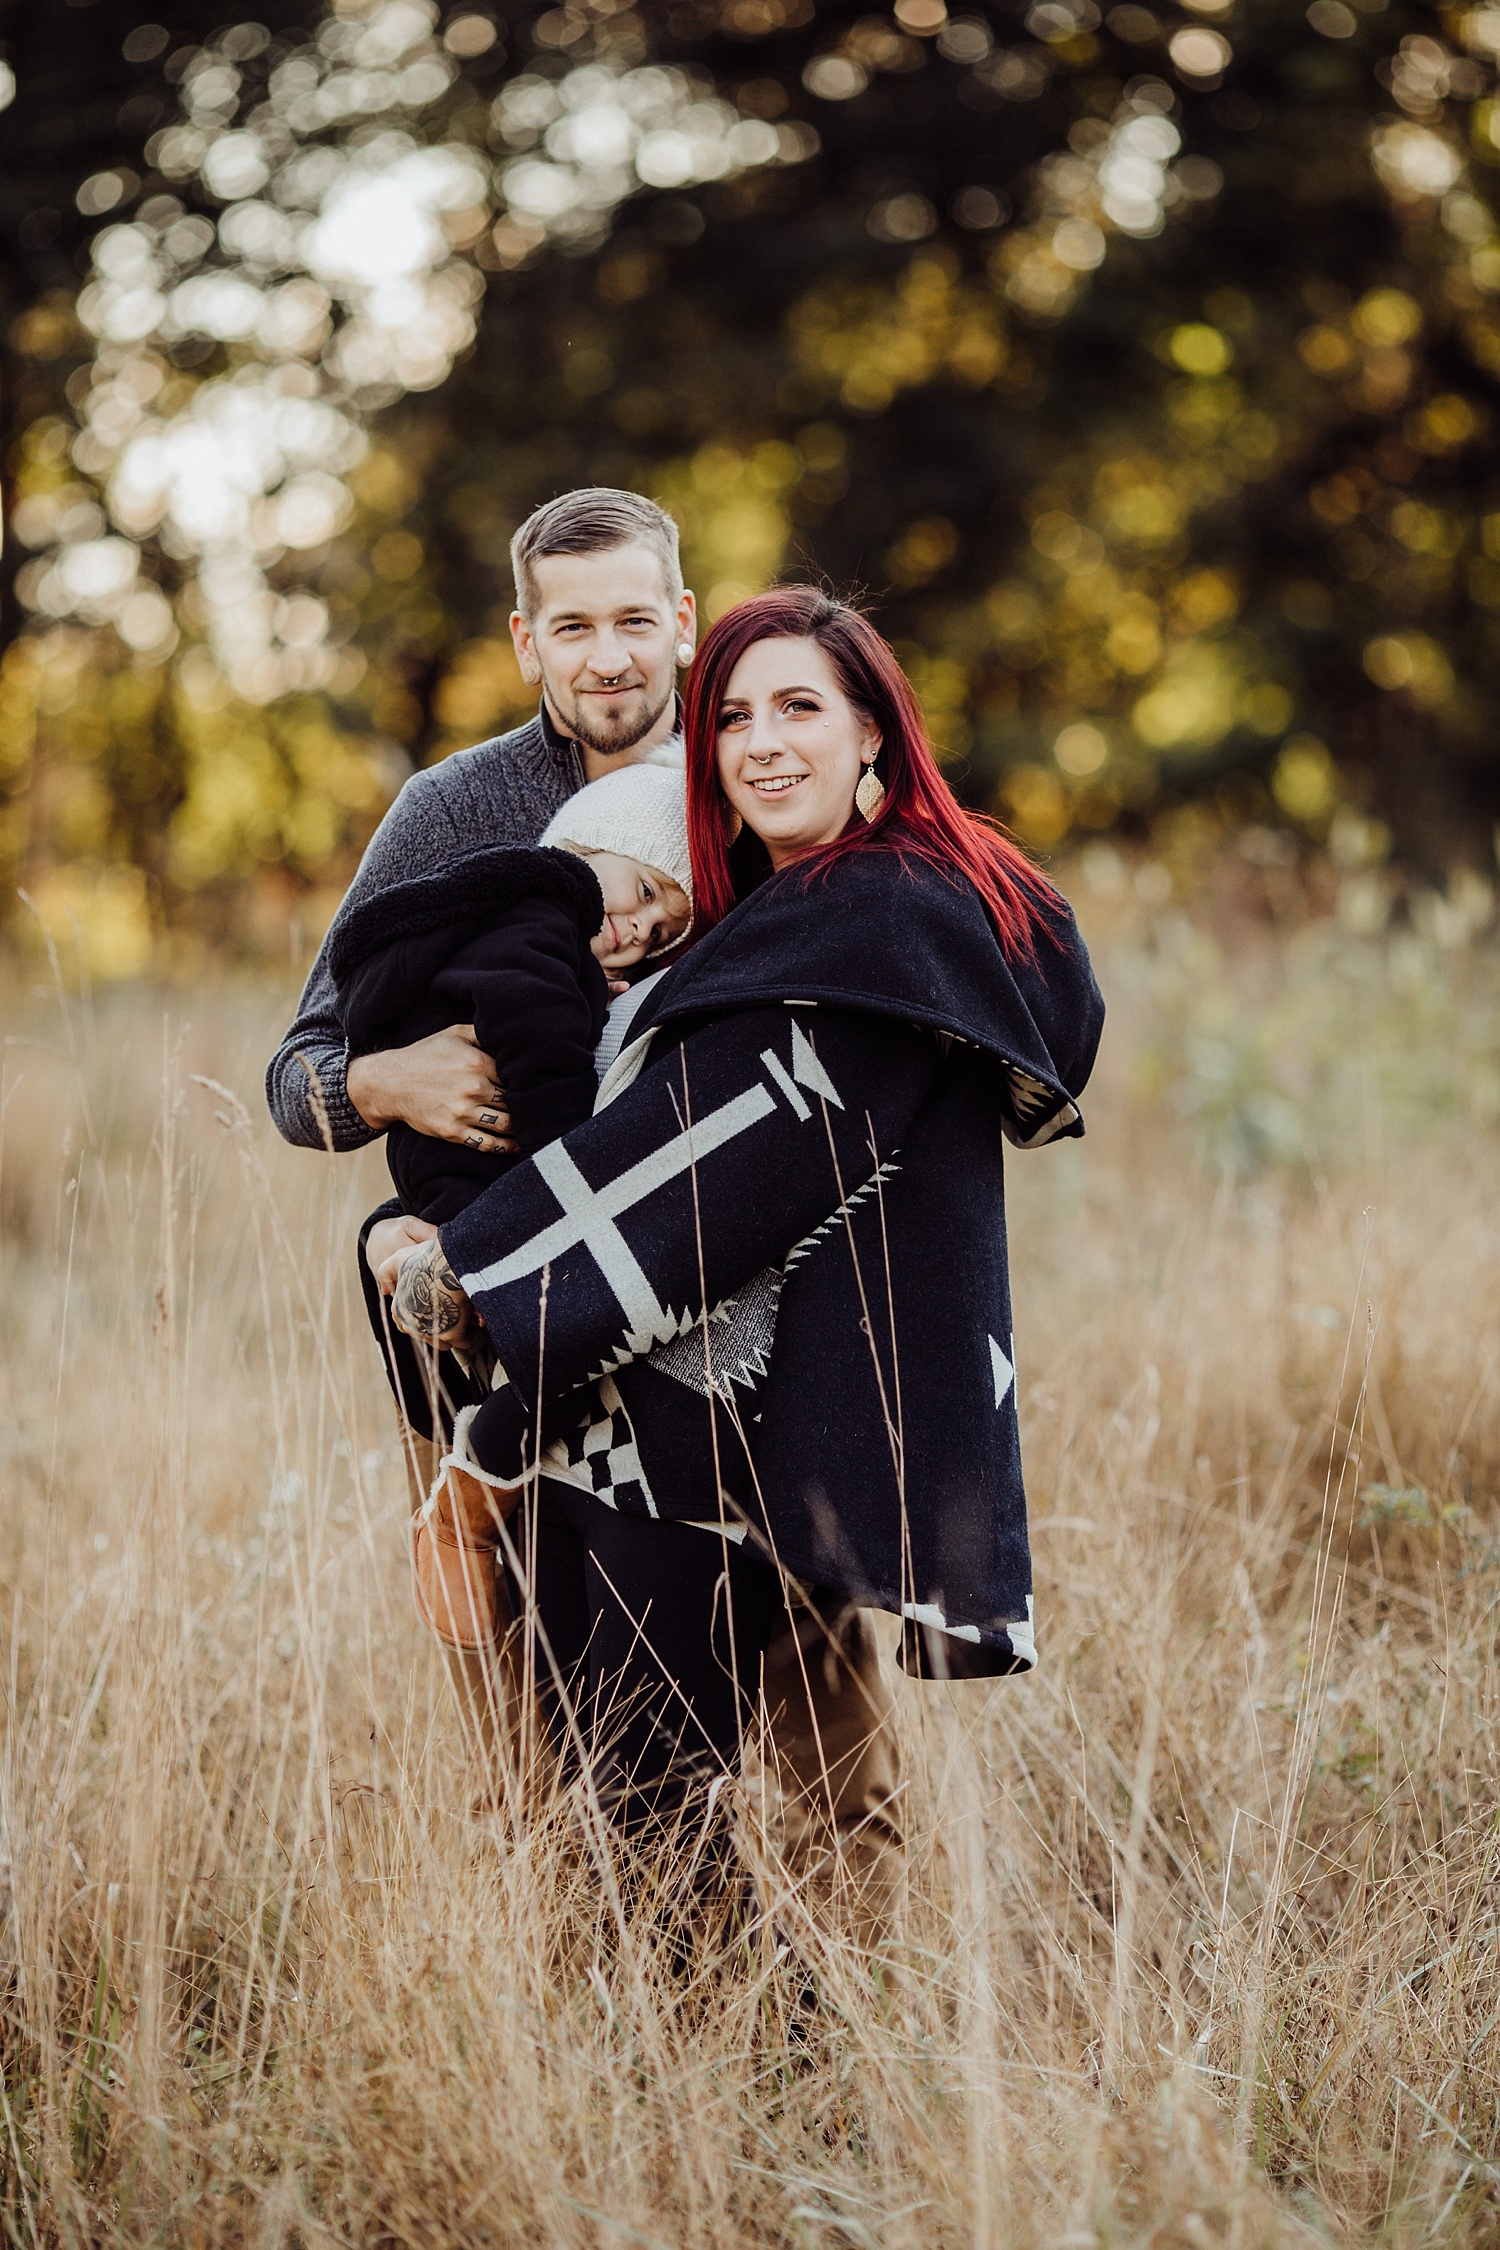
465, 898, 603, 1154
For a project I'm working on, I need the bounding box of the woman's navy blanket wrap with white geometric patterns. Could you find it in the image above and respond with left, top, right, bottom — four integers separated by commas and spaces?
443, 851, 1104, 1676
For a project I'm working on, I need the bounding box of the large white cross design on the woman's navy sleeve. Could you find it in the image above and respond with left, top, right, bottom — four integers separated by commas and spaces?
459, 1085, 776, 1339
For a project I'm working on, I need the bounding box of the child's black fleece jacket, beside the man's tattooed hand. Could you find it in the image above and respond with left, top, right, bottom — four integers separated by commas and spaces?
328, 846, 609, 1224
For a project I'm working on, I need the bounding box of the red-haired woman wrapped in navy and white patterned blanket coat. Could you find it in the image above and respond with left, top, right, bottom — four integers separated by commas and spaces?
375, 587, 1102, 1919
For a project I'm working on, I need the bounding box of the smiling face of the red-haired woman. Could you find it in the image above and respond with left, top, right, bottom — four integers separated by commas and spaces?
717, 641, 879, 869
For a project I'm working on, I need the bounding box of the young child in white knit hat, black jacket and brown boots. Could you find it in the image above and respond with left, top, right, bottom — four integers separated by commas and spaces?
328, 765, 693, 1649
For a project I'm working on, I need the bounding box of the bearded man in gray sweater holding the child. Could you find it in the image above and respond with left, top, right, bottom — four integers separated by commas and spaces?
265, 486, 697, 1152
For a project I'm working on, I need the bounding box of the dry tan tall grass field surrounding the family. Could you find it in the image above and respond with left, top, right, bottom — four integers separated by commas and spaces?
0, 882, 1500, 2250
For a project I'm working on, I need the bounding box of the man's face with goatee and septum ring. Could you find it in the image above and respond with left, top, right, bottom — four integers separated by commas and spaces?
510, 545, 695, 758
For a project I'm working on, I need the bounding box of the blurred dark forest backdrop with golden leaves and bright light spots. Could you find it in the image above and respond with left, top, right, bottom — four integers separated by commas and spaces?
0, 0, 1500, 977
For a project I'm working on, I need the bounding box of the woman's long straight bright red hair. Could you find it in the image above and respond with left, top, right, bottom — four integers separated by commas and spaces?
684, 585, 1057, 959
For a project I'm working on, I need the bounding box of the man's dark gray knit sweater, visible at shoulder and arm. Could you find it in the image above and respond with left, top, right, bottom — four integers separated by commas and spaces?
265, 711, 582, 1150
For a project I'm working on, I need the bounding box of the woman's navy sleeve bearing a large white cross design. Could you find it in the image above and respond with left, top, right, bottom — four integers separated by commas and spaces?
441, 1006, 942, 1476
